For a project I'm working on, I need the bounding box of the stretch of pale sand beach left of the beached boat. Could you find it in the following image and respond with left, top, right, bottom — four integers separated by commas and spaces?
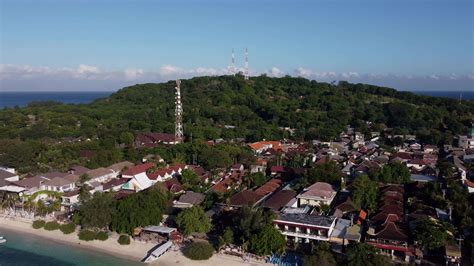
0, 217, 155, 262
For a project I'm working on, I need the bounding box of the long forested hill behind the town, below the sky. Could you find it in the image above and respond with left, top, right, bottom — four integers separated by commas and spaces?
0, 76, 474, 143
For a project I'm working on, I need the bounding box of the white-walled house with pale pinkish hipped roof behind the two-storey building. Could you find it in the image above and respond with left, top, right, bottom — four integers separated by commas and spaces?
296, 182, 337, 206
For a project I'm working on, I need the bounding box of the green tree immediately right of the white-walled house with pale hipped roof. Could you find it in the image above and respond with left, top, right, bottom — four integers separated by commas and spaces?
351, 175, 379, 212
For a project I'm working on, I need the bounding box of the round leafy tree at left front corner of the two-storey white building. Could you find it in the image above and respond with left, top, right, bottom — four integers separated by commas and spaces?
249, 225, 286, 256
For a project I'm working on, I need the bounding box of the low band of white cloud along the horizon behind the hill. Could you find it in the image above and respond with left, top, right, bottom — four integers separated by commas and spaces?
0, 64, 474, 90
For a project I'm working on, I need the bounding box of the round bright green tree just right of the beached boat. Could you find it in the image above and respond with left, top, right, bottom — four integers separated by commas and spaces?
176, 206, 211, 236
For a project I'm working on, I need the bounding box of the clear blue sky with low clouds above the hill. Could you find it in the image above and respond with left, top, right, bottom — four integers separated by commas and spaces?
0, 0, 474, 91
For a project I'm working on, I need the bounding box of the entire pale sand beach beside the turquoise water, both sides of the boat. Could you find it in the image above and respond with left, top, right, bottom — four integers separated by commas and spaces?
0, 217, 270, 266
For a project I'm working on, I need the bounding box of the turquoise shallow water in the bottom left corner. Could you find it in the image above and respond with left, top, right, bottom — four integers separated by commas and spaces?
0, 230, 144, 266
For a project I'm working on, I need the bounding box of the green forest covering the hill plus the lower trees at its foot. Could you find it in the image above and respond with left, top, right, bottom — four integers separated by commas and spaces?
0, 75, 474, 173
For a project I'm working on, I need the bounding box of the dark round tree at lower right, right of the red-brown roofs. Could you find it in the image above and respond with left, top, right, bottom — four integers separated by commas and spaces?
414, 219, 450, 250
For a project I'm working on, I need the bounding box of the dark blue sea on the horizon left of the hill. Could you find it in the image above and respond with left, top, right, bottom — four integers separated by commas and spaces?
0, 91, 112, 109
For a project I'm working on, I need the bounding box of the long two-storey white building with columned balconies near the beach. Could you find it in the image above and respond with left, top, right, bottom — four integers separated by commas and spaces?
273, 213, 336, 243
